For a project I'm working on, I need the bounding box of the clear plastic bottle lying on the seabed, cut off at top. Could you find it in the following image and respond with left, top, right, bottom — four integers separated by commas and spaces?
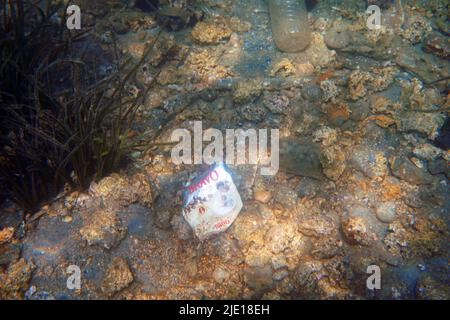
268, 0, 311, 52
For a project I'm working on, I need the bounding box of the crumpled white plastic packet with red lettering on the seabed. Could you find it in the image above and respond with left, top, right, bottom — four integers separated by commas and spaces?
183, 163, 242, 240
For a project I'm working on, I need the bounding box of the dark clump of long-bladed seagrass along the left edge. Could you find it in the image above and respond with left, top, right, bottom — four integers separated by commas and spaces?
0, 0, 161, 212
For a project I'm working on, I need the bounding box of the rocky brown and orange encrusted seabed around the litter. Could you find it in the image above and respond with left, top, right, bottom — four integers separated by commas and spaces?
0, 0, 450, 299
